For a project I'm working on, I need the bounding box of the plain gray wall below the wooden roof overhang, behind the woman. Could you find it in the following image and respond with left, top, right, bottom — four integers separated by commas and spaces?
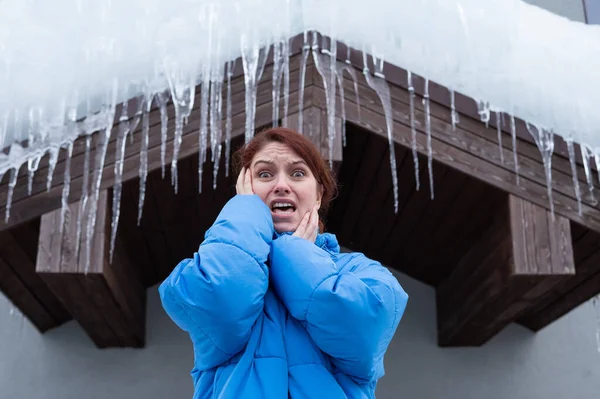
0, 268, 600, 399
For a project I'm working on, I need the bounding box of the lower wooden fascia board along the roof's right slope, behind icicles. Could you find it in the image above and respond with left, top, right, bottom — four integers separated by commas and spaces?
314, 87, 600, 231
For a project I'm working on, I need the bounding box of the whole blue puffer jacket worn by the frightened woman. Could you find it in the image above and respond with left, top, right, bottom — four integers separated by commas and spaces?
159, 195, 408, 399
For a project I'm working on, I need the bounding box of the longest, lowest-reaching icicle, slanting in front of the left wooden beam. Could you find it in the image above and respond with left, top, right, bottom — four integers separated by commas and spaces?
84, 79, 118, 274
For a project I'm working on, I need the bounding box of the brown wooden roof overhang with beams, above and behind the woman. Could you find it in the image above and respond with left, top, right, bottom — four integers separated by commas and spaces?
0, 42, 600, 347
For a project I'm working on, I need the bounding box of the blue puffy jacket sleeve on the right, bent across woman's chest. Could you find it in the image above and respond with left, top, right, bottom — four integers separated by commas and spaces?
271, 235, 408, 383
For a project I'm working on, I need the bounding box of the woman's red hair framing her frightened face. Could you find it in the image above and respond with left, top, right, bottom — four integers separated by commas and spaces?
235, 127, 337, 231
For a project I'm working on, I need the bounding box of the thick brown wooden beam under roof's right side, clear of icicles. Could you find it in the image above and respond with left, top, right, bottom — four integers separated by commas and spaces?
436, 195, 575, 346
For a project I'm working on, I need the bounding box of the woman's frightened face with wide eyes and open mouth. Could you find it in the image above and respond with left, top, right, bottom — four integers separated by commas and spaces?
250, 142, 321, 233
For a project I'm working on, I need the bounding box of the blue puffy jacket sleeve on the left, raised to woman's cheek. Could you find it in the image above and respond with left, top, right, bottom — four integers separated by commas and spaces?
159, 195, 273, 370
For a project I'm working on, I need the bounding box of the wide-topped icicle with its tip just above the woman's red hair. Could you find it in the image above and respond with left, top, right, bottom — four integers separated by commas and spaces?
241, 34, 269, 143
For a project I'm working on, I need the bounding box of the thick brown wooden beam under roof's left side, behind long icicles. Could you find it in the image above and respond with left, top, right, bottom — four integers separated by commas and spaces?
36, 190, 146, 348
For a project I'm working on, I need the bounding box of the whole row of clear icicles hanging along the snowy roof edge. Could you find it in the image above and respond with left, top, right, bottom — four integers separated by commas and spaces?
0, 32, 600, 348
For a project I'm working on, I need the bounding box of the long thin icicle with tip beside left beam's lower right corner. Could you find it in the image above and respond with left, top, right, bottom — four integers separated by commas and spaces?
111, 97, 130, 263
